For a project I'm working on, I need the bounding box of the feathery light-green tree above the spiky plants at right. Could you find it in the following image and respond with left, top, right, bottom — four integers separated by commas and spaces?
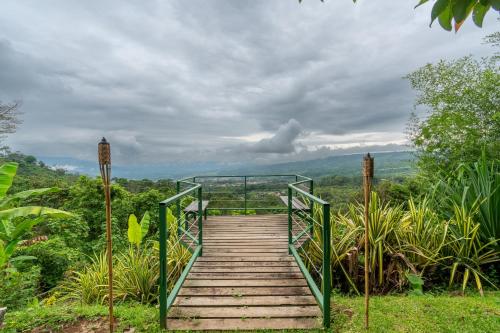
406, 57, 500, 176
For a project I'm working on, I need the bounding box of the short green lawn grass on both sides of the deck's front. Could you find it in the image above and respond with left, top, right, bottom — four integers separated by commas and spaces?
1, 292, 500, 333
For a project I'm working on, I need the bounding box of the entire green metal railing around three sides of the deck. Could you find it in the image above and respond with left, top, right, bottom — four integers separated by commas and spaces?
159, 174, 331, 328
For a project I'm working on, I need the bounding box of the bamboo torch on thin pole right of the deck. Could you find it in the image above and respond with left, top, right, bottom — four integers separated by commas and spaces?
363, 153, 374, 329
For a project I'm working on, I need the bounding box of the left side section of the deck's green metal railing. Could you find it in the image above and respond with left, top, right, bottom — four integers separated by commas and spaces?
160, 180, 203, 328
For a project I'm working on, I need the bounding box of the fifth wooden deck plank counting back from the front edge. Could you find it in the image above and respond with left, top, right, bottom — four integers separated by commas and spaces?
181, 276, 307, 290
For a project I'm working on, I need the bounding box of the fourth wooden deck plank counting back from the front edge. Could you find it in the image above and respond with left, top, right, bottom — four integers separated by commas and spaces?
178, 286, 311, 296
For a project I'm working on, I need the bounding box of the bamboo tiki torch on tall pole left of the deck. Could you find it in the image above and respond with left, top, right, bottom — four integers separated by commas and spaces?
97, 138, 113, 332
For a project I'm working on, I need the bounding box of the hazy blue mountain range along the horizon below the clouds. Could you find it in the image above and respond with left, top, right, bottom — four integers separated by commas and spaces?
40, 151, 415, 179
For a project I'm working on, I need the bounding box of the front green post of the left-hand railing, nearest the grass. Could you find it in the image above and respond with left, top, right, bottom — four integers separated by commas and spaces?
160, 203, 168, 329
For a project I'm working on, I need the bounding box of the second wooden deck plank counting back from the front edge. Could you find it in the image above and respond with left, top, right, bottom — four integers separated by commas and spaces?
168, 305, 321, 318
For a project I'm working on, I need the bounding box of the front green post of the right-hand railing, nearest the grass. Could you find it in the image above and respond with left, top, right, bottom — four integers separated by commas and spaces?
323, 204, 331, 328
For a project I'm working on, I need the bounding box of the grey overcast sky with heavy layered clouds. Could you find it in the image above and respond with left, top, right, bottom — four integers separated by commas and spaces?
0, 0, 499, 164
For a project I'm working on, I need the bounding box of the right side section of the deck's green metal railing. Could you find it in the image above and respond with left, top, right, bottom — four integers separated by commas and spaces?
288, 179, 331, 328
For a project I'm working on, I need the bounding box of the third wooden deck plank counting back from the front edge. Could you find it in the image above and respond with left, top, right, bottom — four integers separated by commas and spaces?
174, 296, 316, 306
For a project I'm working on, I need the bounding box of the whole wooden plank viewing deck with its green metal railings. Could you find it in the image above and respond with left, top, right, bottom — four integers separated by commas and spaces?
160, 175, 331, 330
